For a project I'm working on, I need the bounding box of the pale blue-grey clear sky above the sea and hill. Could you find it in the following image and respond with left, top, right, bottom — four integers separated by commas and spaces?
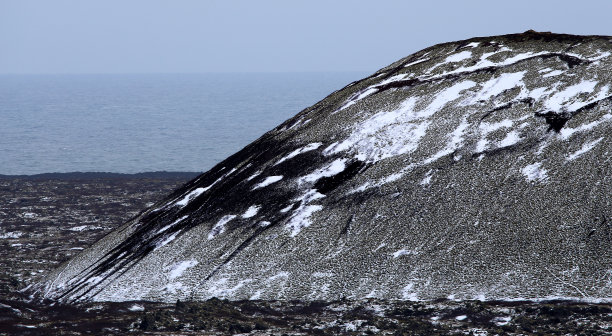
0, 0, 612, 73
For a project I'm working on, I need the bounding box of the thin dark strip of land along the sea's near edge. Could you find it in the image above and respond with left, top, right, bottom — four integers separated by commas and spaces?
0, 171, 203, 180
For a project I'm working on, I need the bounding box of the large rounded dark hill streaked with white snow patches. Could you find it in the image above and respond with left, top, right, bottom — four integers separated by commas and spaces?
36, 32, 612, 302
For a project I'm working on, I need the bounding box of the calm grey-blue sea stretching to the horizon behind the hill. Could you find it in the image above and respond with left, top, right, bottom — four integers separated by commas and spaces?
0, 72, 367, 175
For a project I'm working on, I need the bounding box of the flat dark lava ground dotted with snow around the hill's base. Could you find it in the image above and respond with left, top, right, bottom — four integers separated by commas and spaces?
0, 176, 612, 335
